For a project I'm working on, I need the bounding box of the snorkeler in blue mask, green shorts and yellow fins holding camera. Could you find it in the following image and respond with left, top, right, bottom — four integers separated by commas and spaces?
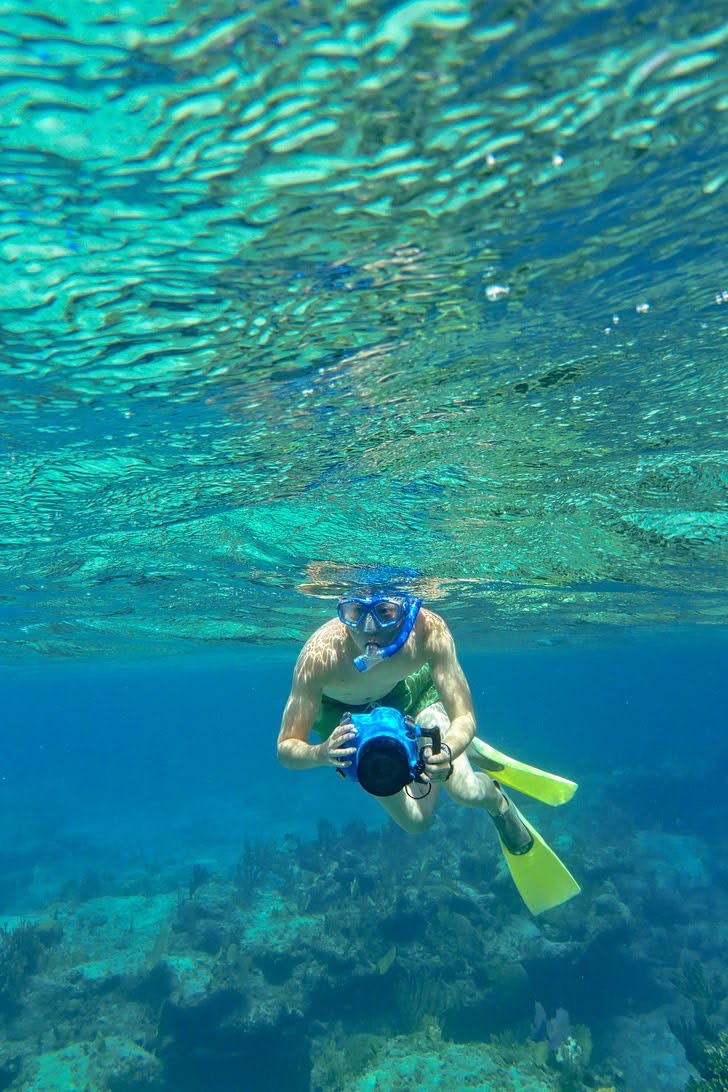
277, 587, 580, 913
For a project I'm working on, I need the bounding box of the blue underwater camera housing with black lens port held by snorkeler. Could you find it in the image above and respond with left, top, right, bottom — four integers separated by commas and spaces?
342, 705, 440, 796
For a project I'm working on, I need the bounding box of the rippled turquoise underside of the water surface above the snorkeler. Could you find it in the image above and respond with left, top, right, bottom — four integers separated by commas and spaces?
0, 0, 728, 655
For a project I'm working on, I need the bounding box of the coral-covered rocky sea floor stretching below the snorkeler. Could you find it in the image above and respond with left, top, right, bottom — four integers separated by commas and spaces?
0, 774, 728, 1092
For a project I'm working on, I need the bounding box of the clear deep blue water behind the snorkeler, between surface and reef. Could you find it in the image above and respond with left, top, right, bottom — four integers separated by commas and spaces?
0, 631, 728, 913
